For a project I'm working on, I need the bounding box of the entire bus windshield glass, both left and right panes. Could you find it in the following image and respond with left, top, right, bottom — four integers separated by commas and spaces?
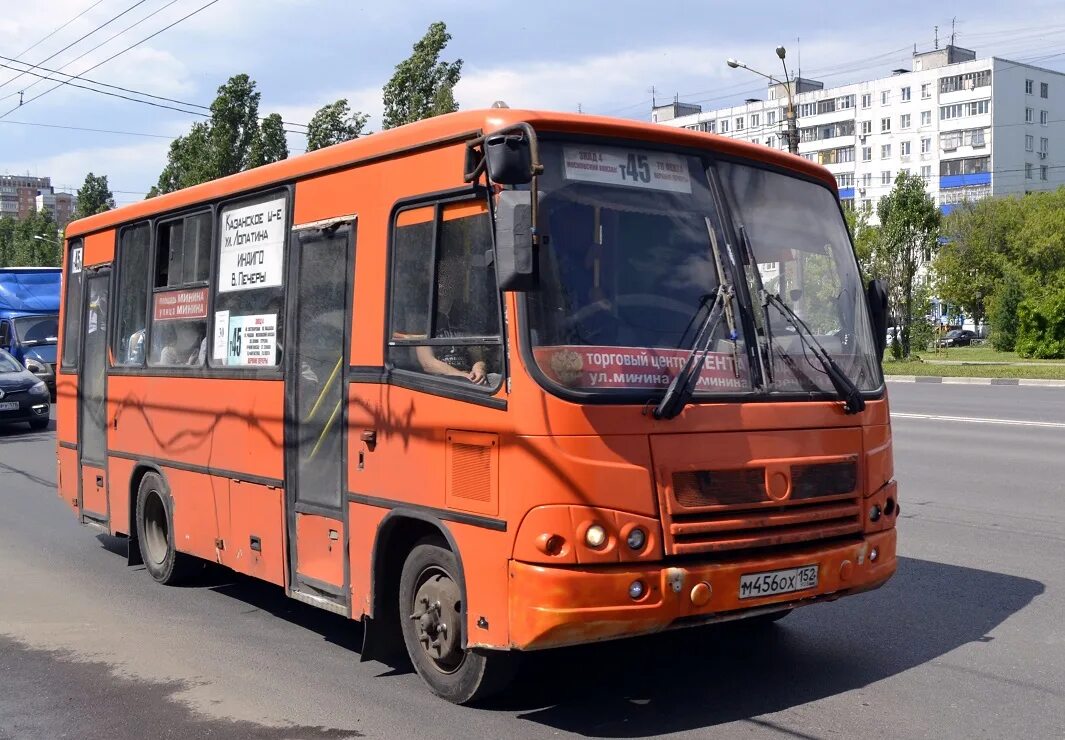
519, 141, 881, 402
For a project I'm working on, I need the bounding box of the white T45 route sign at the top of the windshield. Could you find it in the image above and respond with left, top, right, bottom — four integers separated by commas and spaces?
562, 146, 691, 193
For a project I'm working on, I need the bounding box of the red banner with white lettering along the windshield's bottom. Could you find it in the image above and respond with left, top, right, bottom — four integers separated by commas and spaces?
534, 345, 748, 391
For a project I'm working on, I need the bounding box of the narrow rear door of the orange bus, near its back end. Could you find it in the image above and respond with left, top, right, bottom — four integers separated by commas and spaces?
78, 265, 111, 525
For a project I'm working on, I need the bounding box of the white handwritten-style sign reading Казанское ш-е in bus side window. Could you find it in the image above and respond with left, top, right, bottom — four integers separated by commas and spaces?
218, 195, 289, 293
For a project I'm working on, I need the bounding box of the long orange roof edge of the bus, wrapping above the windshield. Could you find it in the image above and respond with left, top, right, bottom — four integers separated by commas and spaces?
66, 109, 836, 239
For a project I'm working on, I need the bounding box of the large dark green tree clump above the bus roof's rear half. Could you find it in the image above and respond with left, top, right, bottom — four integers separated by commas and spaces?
148, 75, 289, 197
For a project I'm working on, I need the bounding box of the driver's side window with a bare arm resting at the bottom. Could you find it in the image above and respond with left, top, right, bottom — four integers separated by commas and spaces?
389, 203, 503, 389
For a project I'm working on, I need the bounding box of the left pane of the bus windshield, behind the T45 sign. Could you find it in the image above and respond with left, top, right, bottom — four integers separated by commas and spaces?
527, 142, 752, 393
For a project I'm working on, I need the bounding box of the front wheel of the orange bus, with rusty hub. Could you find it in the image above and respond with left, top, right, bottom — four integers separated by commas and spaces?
399, 540, 517, 704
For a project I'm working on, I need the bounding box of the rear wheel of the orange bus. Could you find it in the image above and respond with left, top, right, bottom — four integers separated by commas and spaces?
136, 473, 203, 586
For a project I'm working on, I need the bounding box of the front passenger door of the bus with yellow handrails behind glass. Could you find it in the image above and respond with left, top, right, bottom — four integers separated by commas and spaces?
285, 218, 355, 614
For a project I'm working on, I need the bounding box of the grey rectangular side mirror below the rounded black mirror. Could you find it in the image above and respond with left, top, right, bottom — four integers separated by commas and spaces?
495, 191, 540, 291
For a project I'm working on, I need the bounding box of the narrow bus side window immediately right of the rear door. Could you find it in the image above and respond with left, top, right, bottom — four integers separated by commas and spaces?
111, 223, 151, 366
